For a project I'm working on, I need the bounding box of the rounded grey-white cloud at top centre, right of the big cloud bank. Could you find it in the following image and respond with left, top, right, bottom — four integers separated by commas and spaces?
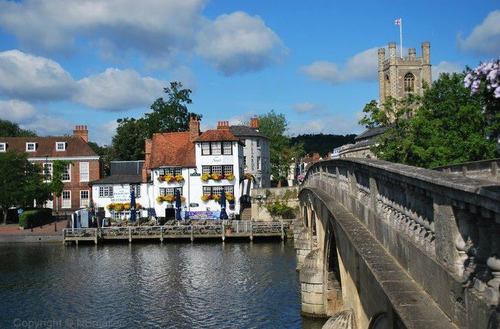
197, 12, 286, 75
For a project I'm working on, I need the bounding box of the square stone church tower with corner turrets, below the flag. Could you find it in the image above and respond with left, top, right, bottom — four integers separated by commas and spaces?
378, 42, 432, 104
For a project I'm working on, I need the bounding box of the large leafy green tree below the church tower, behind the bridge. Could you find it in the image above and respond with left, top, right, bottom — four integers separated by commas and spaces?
371, 74, 497, 168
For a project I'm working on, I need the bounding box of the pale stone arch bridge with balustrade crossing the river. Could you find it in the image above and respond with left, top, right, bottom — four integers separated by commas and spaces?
294, 159, 500, 329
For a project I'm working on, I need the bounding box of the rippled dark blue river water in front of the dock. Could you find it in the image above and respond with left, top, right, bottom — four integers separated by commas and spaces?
0, 242, 323, 329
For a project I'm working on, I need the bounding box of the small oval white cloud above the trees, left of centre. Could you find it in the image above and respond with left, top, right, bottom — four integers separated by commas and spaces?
73, 68, 167, 111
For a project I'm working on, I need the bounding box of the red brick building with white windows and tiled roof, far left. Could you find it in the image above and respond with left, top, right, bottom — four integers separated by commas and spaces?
0, 125, 101, 214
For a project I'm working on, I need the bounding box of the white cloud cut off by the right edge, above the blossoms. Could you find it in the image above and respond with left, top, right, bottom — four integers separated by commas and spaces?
458, 10, 500, 56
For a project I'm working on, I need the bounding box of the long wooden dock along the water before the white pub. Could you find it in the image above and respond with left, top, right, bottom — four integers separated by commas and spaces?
63, 221, 290, 244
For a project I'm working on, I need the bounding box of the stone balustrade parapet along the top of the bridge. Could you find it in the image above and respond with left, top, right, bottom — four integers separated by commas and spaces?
303, 159, 500, 305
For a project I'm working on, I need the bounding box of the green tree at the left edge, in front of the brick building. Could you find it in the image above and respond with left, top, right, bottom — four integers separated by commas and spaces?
0, 152, 28, 225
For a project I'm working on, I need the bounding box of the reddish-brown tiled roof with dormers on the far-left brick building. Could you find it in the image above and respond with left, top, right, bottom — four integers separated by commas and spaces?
0, 136, 97, 158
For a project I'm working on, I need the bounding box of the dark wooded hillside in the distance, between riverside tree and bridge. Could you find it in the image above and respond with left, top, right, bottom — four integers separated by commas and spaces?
290, 134, 356, 156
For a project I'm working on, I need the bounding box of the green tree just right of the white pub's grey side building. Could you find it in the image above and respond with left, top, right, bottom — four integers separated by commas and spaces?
259, 110, 303, 187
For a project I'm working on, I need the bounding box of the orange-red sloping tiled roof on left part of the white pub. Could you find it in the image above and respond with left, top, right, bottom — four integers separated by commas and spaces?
144, 131, 196, 169
